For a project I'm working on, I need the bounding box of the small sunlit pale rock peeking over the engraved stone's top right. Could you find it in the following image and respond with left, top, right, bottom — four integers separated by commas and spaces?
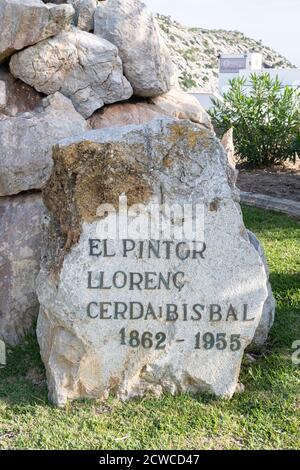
151, 87, 212, 128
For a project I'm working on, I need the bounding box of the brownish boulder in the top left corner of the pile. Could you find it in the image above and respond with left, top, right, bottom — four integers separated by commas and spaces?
0, 0, 74, 62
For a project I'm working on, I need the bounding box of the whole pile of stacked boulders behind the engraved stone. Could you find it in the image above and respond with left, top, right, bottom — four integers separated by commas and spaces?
0, 0, 274, 345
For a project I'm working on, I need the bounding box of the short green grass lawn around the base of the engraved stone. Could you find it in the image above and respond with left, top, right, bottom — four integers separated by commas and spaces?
0, 208, 300, 449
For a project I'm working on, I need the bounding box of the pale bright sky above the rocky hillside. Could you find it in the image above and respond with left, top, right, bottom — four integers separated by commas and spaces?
143, 0, 300, 68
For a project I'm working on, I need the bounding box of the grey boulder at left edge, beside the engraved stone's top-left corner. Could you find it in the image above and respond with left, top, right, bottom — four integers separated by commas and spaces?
0, 93, 89, 196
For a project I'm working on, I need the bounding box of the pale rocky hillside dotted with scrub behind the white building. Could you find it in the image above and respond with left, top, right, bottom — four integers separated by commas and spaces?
157, 15, 294, 91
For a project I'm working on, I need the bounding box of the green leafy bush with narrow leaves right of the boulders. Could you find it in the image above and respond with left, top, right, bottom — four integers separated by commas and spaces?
210, 74, 300, 166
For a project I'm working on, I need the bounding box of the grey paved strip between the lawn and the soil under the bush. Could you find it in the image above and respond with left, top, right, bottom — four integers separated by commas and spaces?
241, 191, 300, 218
